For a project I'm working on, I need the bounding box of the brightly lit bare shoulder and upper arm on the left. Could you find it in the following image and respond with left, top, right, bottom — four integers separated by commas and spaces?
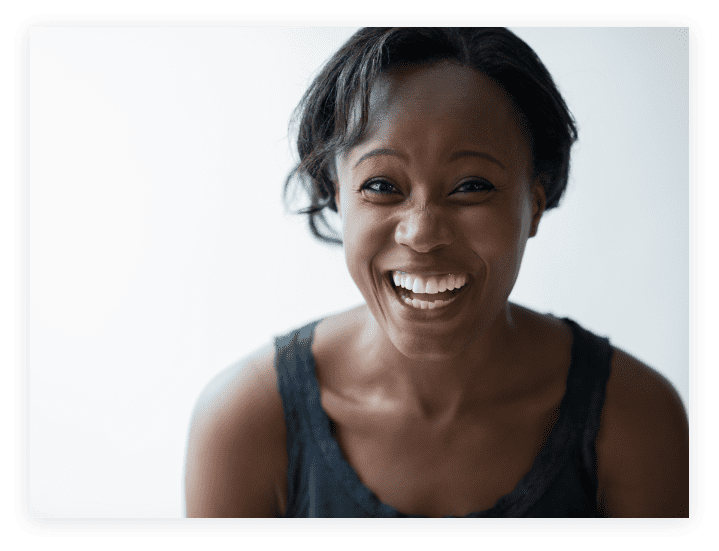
185, 344, 287, 518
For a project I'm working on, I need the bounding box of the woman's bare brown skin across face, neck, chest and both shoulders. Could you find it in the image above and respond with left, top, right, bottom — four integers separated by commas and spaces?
186, 63, 689, 517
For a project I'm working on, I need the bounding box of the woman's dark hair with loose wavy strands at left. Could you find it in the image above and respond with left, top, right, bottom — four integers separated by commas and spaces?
283, 27, 577, 245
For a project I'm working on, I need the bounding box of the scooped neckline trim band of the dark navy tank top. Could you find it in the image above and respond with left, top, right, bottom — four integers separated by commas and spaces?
303, 318, 581, 518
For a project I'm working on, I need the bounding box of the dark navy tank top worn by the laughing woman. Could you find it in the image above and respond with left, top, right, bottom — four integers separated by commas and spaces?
275, 318, 613, 518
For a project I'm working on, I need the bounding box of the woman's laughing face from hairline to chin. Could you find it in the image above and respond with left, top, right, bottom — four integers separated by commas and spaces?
336, 62, 545, 360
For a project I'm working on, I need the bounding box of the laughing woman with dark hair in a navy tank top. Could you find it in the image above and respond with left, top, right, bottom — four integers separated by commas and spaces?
186, 28, 689, 517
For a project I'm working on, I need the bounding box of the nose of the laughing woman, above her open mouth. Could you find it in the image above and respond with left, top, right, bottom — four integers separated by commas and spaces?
395, 203, 452, 253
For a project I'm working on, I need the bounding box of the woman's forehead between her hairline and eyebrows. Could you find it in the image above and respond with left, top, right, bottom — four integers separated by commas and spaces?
344, 61, 528, 166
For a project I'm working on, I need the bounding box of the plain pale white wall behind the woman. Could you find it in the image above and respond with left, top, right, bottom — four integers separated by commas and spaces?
30, 28, 689, 517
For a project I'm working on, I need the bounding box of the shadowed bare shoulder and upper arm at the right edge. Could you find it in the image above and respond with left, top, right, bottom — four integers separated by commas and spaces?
597, 348, 689, 518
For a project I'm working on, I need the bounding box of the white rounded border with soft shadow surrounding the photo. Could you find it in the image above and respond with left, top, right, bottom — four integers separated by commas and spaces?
15, 14, 705, 536
